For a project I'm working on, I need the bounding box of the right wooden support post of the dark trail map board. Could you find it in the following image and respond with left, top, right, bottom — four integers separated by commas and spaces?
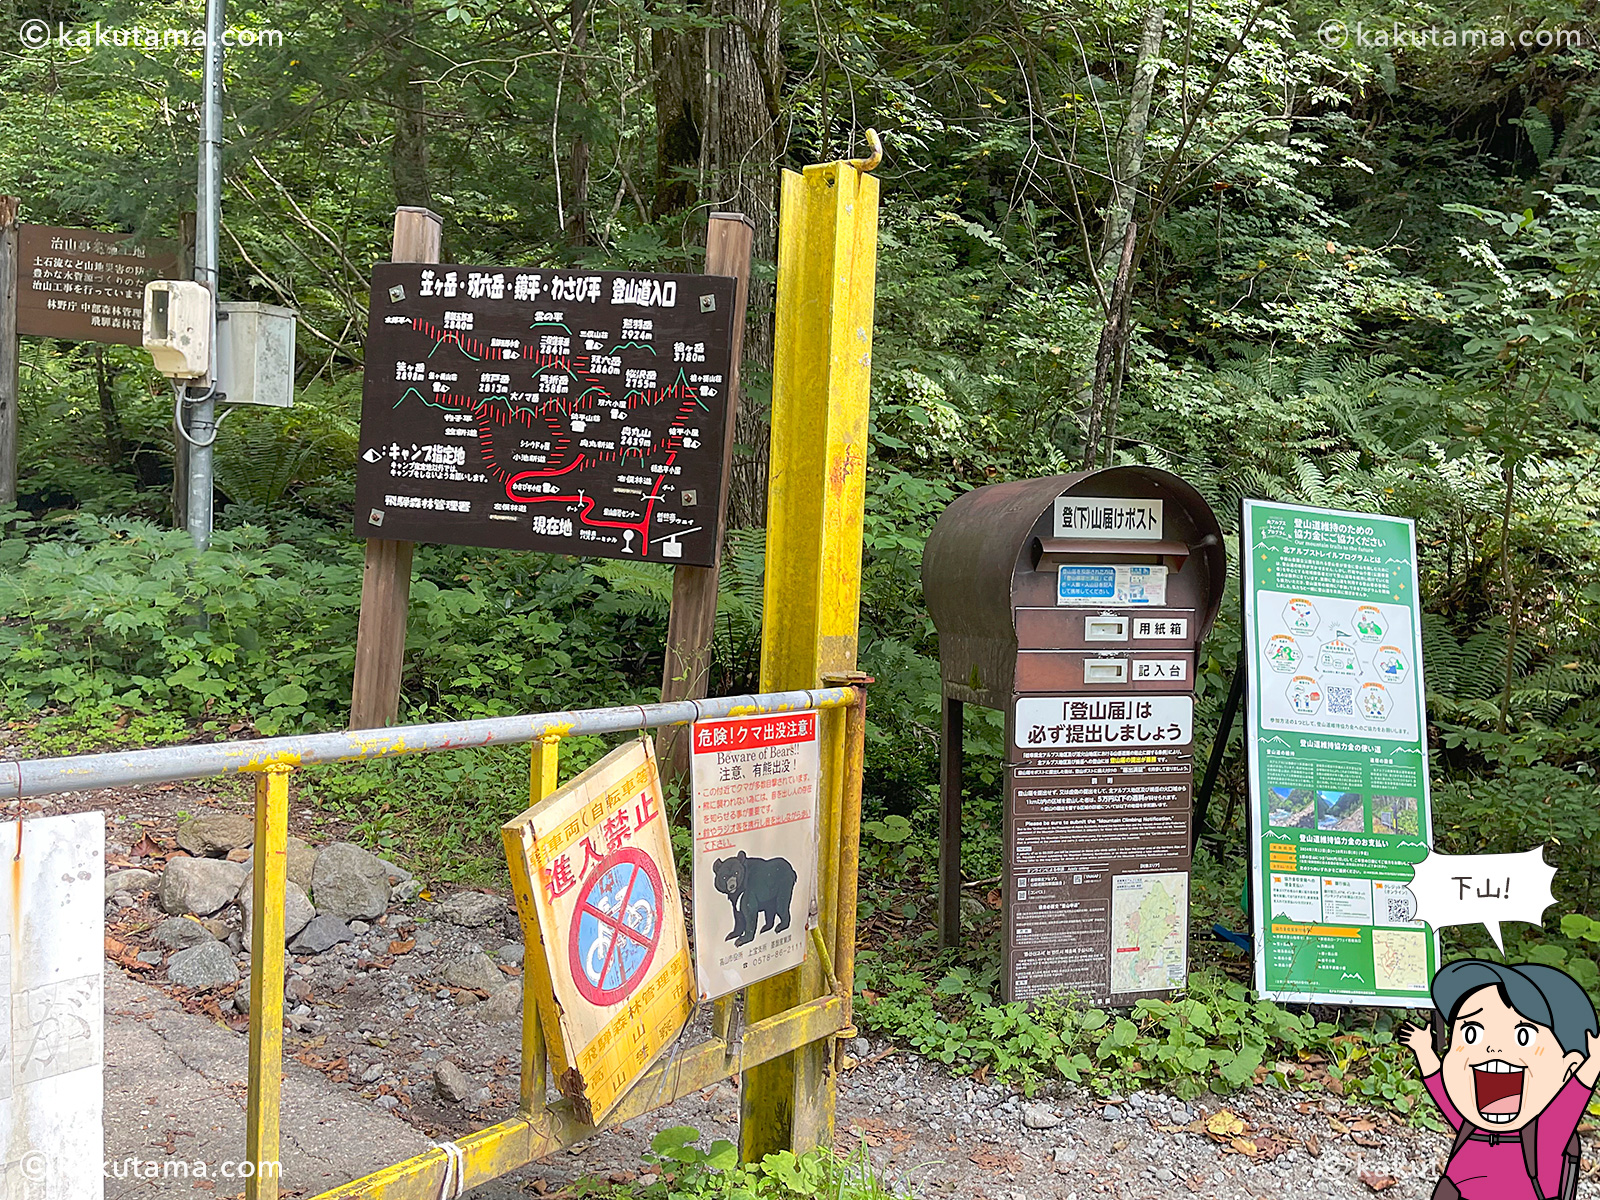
656, 213, 755, 800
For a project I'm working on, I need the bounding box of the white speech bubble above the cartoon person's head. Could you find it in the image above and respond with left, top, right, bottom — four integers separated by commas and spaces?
1411, 846, 1555, 957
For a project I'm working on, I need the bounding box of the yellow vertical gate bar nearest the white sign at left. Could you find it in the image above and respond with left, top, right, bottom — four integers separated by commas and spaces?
245, 766, 293, 1200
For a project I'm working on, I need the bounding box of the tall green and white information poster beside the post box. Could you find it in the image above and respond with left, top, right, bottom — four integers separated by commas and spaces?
1240, 501, 1438, 1006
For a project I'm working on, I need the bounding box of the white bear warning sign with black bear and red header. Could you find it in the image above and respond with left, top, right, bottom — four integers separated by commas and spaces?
693, 710, 822, 1000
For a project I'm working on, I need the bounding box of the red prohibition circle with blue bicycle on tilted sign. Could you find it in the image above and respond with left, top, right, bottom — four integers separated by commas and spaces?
566, 846, 664, 1005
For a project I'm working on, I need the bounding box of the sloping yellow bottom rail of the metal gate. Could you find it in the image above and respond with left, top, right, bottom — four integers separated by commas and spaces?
302, 995, 845, 1200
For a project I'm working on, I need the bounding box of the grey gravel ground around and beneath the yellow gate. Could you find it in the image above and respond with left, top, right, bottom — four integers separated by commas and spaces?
6, 755, 1600, 1200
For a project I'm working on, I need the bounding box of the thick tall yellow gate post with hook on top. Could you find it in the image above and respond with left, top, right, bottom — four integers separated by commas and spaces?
739, 131, 882, 1162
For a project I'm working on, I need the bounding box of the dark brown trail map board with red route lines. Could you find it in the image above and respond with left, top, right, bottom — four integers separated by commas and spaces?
355, 262, 736, 566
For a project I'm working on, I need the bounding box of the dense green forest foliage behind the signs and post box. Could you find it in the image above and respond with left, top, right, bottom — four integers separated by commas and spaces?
0, 0, 1600, 1120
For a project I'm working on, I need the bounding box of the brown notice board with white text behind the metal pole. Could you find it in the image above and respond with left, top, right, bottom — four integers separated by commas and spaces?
16, 226, 178, 346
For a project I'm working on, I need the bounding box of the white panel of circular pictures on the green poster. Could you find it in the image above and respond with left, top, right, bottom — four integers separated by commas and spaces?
1256, 590, 1419, 741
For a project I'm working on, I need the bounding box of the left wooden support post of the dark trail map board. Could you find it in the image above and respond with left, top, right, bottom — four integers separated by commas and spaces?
350, 208, 445, 730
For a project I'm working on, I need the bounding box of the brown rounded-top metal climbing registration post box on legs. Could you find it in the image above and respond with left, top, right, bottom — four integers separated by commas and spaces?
922, 467, 1227, 1003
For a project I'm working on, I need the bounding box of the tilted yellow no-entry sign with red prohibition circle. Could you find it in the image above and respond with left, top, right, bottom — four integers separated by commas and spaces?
501, 739, 694, 1125
